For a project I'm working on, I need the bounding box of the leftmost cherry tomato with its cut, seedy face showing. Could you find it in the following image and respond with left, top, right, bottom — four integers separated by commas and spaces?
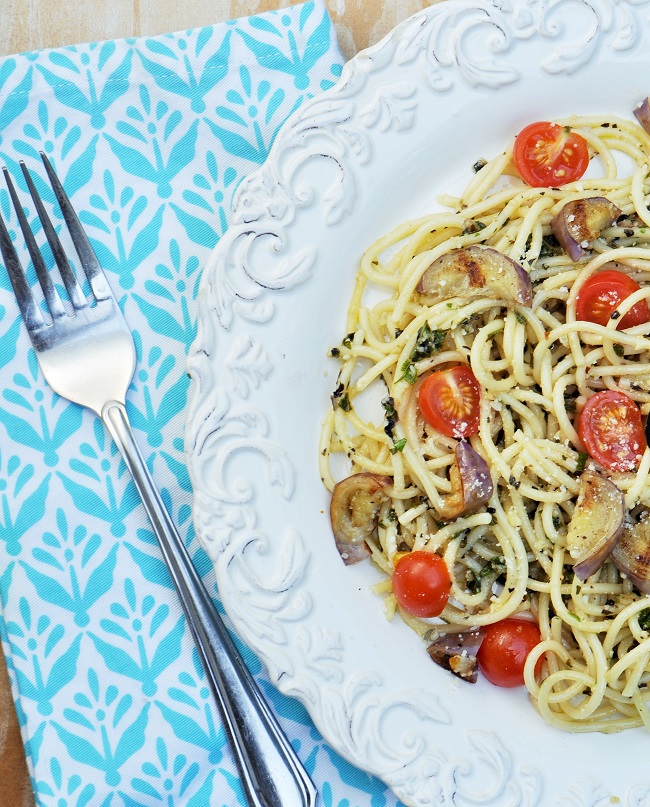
418, 364, 481, 439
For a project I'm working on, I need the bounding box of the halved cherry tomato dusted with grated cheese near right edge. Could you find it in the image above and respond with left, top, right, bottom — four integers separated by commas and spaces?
578, 389, 646, 471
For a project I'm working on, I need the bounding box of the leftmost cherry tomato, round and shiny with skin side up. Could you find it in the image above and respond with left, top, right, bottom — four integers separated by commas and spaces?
393, 550, 451, 618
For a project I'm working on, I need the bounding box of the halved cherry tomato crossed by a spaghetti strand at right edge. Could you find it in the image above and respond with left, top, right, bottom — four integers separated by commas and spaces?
576, 269, 650, 331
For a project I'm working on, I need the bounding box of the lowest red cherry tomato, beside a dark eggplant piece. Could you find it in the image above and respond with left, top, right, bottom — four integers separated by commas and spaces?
476, 618, 542, 687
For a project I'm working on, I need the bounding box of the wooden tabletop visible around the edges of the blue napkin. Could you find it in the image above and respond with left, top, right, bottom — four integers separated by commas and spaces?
0, 0, 432, 807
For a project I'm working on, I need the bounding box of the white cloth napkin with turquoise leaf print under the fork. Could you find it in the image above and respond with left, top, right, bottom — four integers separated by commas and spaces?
0, 2, 404, 807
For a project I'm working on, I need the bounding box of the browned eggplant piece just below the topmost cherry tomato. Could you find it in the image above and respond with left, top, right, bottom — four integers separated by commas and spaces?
551, 196, 622, 261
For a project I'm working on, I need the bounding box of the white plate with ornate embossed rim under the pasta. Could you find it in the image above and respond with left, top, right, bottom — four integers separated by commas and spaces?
186, 0, 650, 807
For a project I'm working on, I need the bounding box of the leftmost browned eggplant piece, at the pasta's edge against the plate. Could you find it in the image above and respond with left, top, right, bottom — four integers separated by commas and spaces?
330, 473, 393, 566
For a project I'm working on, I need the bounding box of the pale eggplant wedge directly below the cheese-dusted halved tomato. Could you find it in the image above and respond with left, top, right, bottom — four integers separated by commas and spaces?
566, 471, 625, 580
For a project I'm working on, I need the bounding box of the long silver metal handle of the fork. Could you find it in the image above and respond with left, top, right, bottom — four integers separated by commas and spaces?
102, 401, 317, 807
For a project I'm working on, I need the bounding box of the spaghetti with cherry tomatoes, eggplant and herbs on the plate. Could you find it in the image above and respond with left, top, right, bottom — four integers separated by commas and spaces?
319, 110, 650, 732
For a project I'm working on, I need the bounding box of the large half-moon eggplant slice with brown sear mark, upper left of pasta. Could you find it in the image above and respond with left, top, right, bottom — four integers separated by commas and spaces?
418, 245, 533, 307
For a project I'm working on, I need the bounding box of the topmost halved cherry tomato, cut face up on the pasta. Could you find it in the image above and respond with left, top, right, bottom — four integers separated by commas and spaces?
512, 121, 589, 188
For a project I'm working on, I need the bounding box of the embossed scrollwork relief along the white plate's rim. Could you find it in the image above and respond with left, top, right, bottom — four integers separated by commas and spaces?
187, 0, 647, 807
